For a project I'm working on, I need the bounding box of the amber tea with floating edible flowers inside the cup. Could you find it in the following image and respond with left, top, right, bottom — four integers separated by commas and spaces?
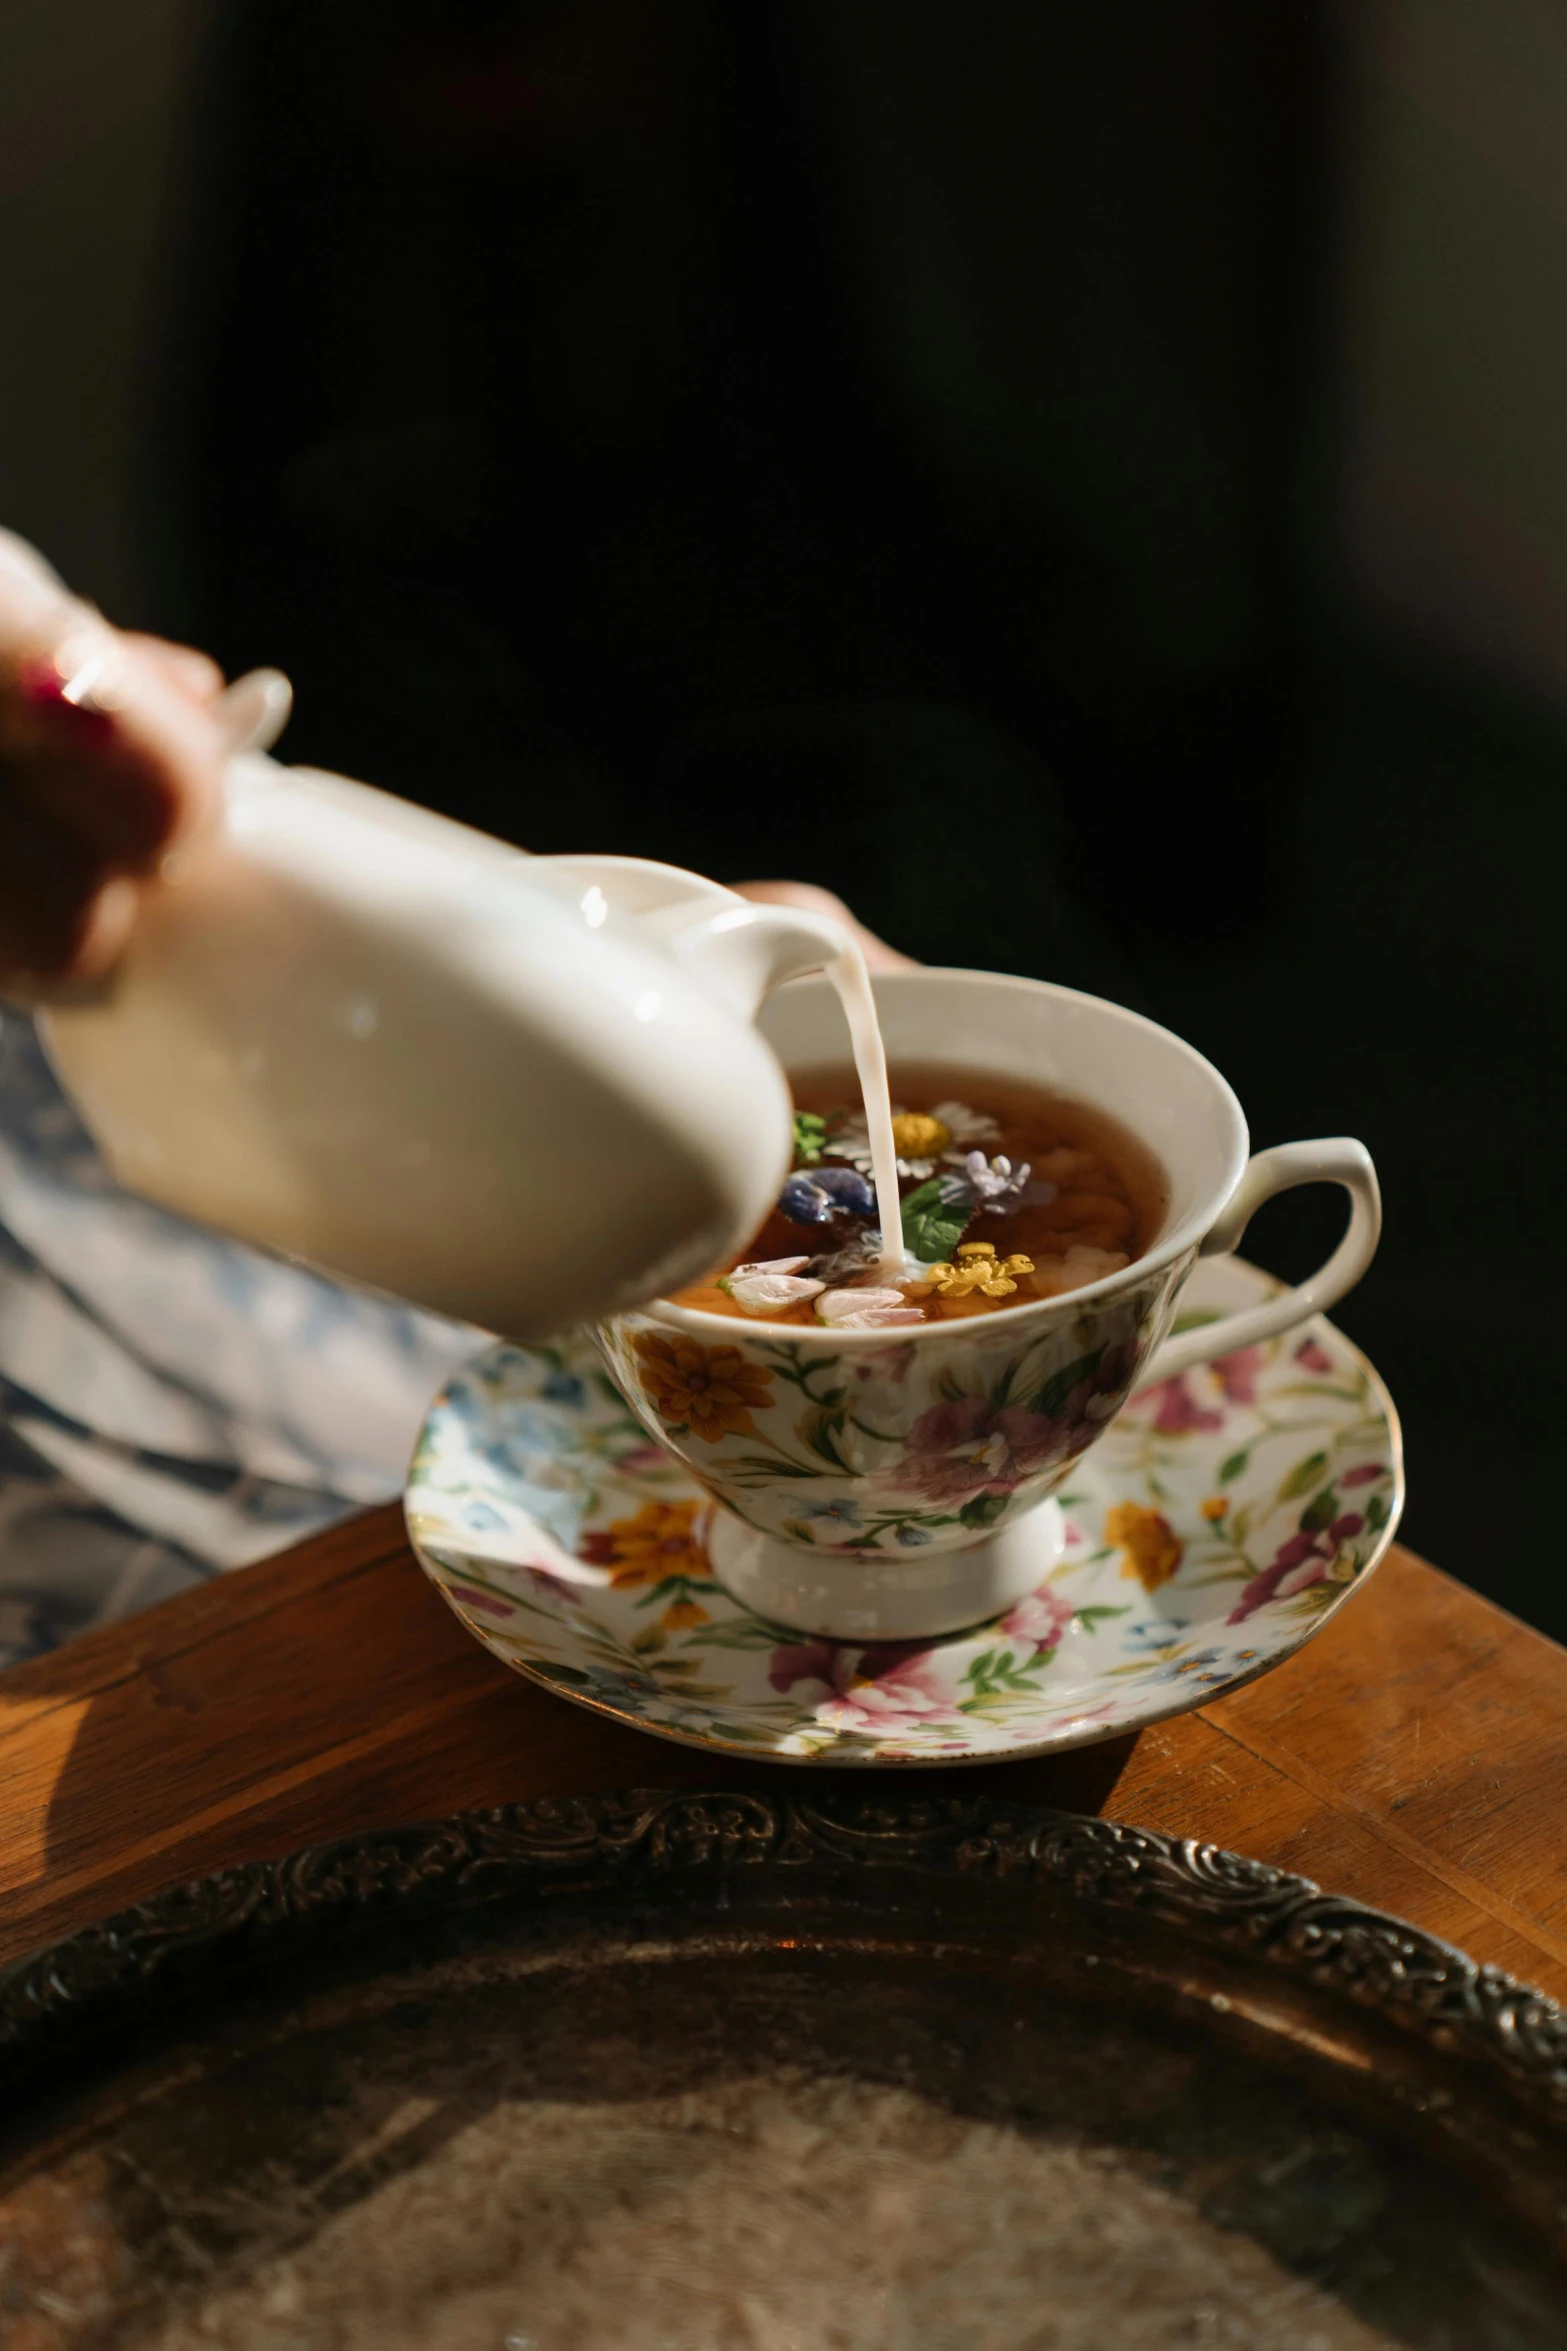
674, 1063, 1165, 1328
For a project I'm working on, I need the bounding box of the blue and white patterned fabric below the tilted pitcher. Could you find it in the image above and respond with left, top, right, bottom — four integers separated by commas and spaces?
0, 1009, 482, 1665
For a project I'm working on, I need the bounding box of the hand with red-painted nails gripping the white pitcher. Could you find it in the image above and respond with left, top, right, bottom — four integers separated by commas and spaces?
0, 531, 233, 987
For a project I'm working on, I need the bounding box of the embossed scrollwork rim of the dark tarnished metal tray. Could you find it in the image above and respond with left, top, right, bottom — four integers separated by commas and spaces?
0, 1789, 1567, 2151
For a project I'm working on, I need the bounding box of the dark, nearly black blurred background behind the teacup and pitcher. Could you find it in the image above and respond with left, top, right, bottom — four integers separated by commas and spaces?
0, 0, 1567, 1634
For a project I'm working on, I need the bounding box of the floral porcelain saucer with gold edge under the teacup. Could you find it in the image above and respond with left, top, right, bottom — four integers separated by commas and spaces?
406, 1258, 1405, 1766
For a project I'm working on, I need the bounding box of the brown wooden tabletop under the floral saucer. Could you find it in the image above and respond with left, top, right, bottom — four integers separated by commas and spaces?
0, 1509, 1567, 1998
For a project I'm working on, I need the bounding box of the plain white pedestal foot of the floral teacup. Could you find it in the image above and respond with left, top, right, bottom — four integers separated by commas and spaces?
707, 1502, 1067, 1641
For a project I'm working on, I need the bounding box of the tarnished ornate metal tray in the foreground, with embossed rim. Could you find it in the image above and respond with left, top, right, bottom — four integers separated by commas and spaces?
0, 1791, 1567, 2351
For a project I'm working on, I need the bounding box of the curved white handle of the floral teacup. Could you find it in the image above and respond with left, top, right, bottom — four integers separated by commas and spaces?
1142, 1136, 1381, 1387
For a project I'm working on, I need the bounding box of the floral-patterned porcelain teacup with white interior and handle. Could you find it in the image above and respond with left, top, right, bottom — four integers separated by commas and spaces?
597, 971, 1381, 1641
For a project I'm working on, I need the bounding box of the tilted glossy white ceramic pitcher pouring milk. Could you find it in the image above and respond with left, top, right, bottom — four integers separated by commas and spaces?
30, 752, 848, 1338
